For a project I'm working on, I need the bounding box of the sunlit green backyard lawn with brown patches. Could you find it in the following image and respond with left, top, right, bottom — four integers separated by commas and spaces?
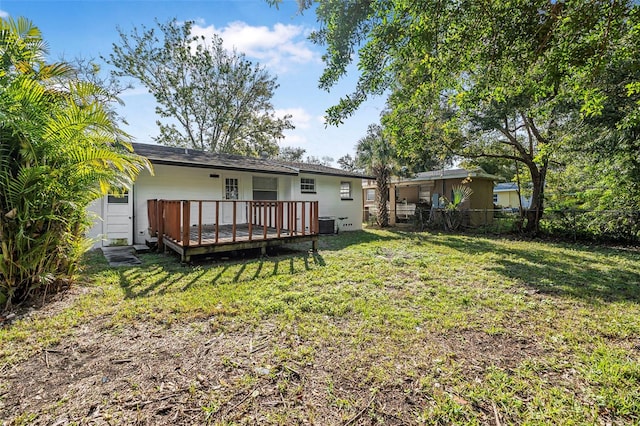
0, 230, 640, 425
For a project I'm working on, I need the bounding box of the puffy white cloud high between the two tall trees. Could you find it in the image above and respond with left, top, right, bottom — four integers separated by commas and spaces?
192, 21, 320, 72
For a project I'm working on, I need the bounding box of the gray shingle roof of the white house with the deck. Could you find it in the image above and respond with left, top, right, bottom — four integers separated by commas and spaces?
131, 143, 366, 178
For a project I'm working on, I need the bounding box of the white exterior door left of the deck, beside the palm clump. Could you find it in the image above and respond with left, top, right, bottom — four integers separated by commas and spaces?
103, 192, 133, 246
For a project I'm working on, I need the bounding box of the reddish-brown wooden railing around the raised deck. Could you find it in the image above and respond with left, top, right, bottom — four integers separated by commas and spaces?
147, 200, 319, 247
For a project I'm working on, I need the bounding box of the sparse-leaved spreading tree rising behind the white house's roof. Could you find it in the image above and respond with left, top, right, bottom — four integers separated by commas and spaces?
109, 19, 293, 156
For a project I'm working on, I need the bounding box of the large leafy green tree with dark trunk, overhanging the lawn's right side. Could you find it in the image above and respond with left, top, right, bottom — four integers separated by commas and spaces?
282, 0, 640, 232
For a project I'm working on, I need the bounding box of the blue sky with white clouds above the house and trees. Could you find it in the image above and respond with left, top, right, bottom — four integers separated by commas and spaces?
0, 0, 384, 160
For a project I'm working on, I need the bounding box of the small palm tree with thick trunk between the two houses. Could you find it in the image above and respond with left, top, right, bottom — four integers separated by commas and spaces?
356, 124, 395, 227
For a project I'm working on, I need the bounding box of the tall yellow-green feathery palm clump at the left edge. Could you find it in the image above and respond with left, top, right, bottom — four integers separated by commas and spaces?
0, 18, 149, 305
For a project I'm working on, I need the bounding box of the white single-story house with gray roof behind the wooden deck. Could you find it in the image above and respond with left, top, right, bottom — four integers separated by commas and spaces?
89, 143, 365, 251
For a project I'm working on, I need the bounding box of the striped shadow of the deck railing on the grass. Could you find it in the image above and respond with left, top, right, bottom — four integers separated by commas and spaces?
117, 248, 326, 299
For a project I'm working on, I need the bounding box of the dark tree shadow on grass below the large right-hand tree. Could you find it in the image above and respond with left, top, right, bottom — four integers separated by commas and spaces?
424, 236, 640, 304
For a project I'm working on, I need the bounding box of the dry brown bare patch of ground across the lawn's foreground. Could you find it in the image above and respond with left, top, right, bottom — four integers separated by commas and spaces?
0, 304, 552, 425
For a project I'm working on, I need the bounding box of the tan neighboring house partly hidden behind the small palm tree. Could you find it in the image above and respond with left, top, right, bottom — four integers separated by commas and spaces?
363, 169, 501, 226
